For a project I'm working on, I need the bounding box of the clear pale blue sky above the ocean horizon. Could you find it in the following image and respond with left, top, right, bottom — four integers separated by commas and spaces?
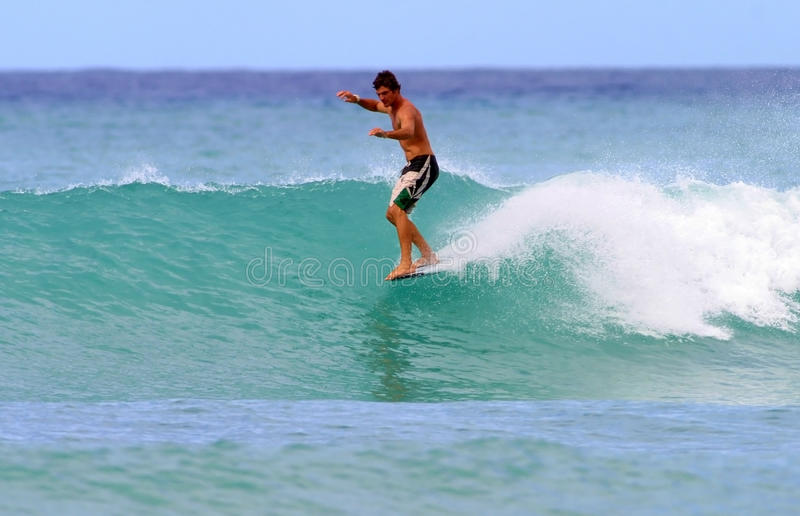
0, 0, 800, 70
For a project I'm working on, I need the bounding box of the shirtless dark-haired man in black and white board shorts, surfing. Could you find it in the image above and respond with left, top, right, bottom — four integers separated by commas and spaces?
336, 70, 439, 280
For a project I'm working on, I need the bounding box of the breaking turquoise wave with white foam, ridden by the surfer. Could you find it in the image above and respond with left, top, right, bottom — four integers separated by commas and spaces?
0, 172, 800, 402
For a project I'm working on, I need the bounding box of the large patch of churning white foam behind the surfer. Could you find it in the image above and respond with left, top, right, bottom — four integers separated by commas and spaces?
440, 172, 800, 338
